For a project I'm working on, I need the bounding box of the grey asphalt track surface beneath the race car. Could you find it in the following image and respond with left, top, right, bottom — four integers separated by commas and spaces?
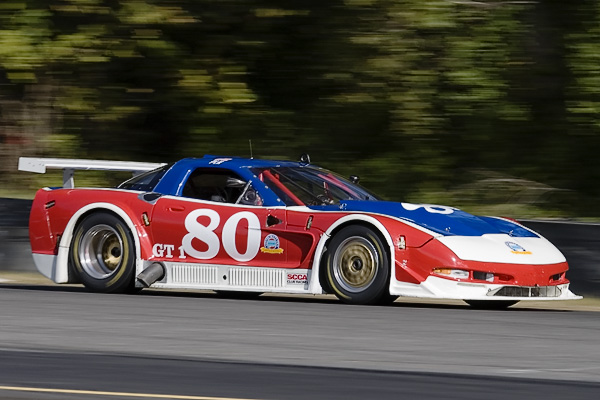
0, 283, 600, 400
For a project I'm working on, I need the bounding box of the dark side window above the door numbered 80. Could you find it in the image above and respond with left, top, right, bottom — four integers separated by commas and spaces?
181, 168, 262, 205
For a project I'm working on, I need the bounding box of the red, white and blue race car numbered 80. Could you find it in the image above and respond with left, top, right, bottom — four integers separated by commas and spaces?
19, 155, 581, 308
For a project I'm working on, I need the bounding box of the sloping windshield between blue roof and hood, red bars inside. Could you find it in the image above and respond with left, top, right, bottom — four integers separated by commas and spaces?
252, 167, 379, 206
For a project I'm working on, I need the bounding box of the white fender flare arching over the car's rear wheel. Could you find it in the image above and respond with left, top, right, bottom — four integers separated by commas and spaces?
55, 203, 143, 283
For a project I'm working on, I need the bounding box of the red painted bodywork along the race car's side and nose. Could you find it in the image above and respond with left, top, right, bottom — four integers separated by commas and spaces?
30, 189, 568, 286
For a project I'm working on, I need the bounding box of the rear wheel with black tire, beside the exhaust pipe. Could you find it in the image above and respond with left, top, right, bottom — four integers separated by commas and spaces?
69, 212, 139, 293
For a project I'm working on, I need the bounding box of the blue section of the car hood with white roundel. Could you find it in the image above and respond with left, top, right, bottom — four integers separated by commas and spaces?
310, 200, 538, 237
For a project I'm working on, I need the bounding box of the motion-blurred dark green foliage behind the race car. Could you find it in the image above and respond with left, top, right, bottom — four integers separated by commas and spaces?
0, 0, 600, 217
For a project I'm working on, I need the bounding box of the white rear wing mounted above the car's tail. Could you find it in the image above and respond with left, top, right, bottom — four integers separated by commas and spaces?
19, 157, 165, 189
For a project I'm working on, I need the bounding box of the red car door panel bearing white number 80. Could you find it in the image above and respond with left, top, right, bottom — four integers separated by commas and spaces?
151, 196, 306, 268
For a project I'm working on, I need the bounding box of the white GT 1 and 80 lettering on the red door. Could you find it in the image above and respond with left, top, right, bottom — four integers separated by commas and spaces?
152, 209, 261, 262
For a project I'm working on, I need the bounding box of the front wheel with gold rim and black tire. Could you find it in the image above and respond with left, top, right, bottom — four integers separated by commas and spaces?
325, 225, 395, 304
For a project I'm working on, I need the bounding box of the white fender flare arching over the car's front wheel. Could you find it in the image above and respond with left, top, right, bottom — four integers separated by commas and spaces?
308, 214, 396, 294
